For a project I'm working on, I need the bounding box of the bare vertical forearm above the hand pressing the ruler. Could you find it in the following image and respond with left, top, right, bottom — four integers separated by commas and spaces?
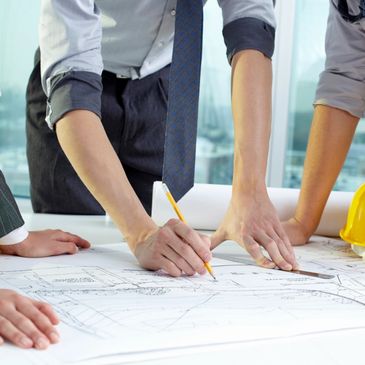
232, 50, 272, 197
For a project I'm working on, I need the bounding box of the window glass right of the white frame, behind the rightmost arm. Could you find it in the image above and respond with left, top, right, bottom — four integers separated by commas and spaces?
281, 0, 365, 191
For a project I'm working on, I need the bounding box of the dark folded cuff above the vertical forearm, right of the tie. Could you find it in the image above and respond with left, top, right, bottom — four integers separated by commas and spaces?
223, 17, 275, 63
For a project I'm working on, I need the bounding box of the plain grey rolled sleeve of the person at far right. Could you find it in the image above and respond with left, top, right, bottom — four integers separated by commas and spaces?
314, 2, 365, 118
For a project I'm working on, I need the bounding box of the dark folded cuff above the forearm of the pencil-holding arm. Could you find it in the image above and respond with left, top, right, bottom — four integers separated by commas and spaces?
46, 71, 103, 129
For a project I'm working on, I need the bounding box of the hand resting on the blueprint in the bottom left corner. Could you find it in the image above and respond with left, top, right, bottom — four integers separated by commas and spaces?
0, 289, 59, 350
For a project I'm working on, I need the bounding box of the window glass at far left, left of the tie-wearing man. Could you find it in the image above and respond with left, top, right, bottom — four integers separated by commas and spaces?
0, 0, 40, 196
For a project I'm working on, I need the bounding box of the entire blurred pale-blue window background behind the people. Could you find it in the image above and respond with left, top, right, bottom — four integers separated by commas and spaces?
0, 0, 365, 197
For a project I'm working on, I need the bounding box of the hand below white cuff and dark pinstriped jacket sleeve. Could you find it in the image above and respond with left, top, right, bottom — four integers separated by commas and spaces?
0, 229, 90, 257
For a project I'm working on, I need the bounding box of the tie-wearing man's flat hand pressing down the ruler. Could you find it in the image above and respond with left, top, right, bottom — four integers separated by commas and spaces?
211, 195, 298, 270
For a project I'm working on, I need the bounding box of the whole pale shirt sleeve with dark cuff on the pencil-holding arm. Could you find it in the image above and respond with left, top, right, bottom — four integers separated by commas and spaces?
39, 0, 103, 128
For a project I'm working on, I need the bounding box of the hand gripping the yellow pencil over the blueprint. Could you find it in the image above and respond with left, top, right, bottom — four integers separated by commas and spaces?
134, 219, 212, 276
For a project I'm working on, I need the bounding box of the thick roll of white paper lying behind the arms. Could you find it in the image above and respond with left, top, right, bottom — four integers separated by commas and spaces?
152, 182, 353, 237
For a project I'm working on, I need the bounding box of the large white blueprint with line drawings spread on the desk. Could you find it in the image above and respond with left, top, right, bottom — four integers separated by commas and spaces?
0, 237, 365, 364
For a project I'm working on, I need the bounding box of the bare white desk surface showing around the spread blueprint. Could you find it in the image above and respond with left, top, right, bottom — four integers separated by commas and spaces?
7, 213, 365, 365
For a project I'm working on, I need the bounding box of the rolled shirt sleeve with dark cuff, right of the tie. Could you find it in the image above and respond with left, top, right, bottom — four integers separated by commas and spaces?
218, 0, 276, 63
